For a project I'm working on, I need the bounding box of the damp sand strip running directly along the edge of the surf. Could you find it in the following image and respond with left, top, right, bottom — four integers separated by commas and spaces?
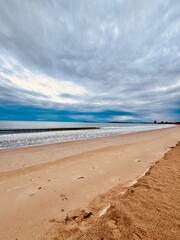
0, 126, 177, 174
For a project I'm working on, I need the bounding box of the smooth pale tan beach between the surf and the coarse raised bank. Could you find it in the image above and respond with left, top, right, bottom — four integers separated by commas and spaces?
0, 127, 180, 240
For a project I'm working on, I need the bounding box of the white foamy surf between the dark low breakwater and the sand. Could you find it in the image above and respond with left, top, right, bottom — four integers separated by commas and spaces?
0, 124, 173, 149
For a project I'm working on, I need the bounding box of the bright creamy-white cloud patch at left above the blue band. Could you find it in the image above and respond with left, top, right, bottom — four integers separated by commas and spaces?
0, 57, 87, 104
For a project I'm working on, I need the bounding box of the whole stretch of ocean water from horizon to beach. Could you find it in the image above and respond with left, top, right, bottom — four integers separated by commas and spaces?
0, 121, 173, 149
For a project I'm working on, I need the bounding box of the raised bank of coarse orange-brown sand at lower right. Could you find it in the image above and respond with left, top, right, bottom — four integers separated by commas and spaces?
43, 142, 180, 240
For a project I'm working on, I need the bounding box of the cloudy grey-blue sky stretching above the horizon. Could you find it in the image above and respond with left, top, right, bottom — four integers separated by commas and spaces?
0, 0, 180, 122
